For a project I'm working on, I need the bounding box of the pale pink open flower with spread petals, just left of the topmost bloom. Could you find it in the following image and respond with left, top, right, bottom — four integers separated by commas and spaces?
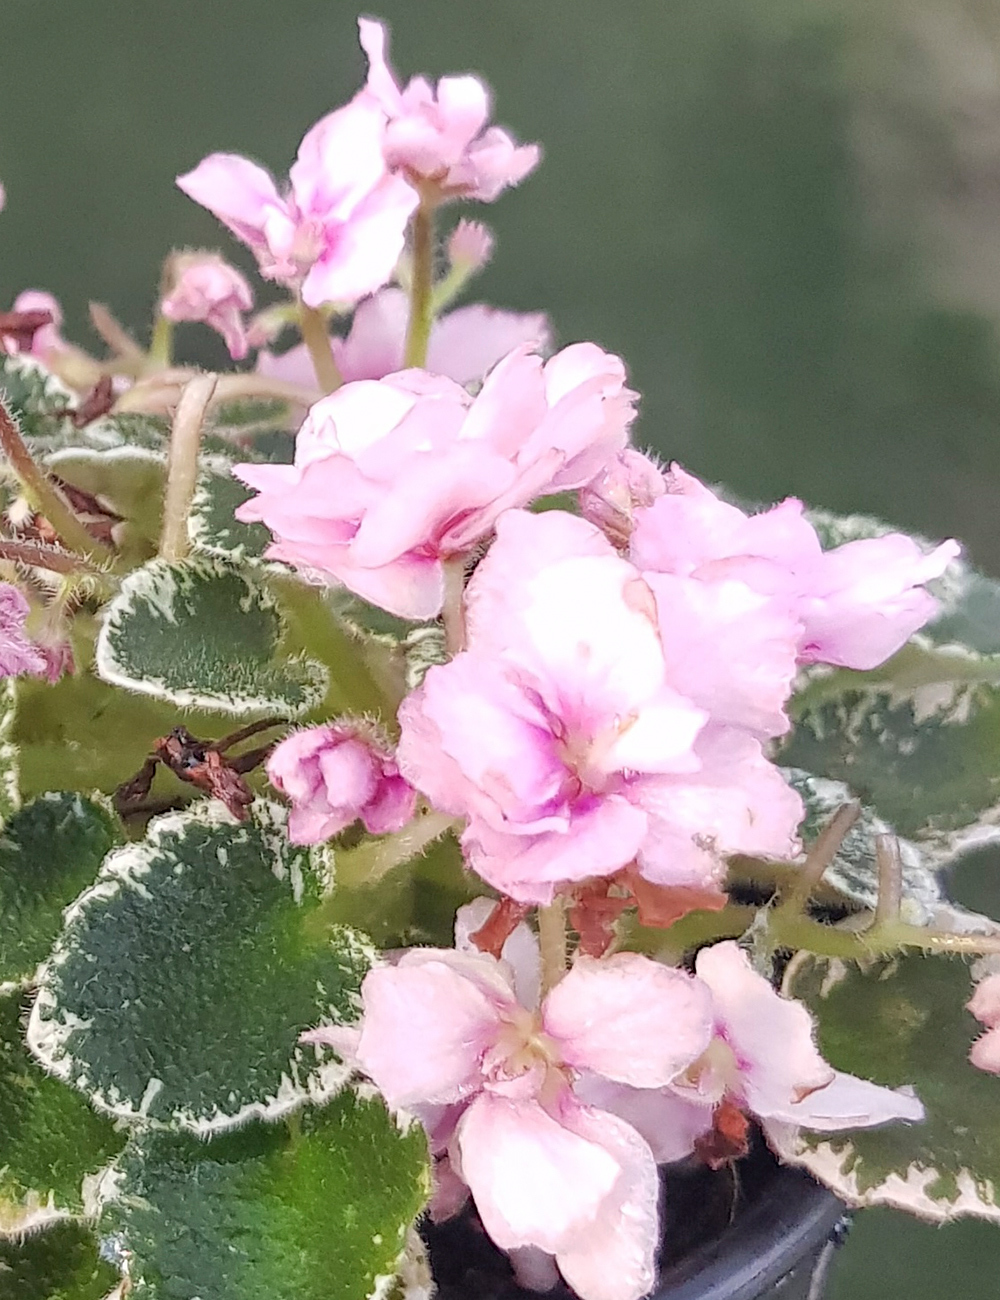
177, 99, 417, 307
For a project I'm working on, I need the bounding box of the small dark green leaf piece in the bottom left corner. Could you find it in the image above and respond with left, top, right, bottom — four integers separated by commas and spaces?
0, 1223, 120, 1300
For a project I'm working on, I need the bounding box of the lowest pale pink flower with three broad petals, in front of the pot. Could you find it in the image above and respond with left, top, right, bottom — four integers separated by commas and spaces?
307, 948, 713, 1300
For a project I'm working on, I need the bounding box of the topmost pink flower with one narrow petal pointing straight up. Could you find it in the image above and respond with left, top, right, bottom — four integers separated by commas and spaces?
358, 18, 541, 203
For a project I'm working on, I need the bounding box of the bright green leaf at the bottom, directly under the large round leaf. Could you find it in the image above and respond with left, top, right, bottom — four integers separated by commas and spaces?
101, 1089, 429, 1300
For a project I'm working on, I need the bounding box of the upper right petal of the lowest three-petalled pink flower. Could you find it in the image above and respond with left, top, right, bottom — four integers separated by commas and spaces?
542, 953, 714, 1088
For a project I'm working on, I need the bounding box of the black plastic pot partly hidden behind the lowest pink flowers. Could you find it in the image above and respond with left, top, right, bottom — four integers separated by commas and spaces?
424, 1145, 848, 1300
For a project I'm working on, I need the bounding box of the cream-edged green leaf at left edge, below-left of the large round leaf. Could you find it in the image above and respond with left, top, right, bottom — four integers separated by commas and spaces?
0, 993, 125, 1237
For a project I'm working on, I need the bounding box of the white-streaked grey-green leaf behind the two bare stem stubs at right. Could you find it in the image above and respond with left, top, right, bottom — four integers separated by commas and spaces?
783, 767, 944, 926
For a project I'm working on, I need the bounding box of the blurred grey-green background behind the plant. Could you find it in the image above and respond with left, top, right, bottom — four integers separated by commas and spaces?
0, 0, 1000, 1300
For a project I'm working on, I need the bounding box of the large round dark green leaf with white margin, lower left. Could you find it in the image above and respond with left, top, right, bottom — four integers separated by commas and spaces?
27, 801, 373, 1135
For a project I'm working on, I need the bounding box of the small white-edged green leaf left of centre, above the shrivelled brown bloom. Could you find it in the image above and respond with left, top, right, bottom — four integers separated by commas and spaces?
96, 559, 326, 716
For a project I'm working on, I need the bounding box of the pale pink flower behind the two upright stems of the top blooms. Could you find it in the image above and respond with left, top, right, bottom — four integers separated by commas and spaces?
257, 289, 550, 387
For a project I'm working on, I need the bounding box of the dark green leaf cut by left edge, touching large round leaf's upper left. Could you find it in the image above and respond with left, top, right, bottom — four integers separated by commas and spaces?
0, 792, 121, 993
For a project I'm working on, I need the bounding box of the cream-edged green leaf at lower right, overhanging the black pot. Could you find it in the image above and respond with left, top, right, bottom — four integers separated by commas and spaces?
769, 954, 1000, 1222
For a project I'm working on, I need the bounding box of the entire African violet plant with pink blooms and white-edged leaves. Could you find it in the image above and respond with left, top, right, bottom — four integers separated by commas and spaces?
0, 21, 1000, 1300
